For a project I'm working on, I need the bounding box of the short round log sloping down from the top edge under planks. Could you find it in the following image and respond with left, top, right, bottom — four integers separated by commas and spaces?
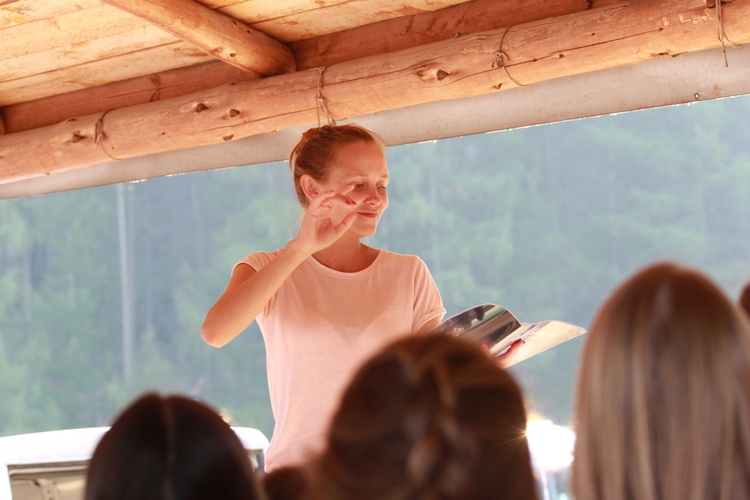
103, 0, 296, 76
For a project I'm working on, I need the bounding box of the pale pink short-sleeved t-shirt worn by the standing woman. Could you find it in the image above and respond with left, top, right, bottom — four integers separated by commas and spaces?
238, 250, 445, 470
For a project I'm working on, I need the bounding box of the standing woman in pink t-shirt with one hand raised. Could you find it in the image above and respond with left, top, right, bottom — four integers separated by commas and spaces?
201, 125, 445, 471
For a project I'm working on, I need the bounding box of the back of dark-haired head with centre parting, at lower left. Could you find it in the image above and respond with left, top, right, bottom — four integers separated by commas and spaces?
85, 393, 263, 500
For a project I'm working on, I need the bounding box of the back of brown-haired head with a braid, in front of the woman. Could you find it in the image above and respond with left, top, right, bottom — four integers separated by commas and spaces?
311, 334, 536, 500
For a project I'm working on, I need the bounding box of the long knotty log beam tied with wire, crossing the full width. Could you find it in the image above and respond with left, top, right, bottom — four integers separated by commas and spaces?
0, 0, 750, 182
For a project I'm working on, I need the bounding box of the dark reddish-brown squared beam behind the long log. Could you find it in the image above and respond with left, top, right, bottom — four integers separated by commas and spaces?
1, 0, 621, 133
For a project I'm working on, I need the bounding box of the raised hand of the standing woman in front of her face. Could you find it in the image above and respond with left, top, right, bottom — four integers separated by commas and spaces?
294, 184, 357, 255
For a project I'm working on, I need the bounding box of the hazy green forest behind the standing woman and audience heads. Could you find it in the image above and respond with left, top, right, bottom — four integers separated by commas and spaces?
0, 97, 750, 436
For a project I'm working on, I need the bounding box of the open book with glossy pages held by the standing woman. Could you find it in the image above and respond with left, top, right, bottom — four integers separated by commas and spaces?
434, 304, 586, 367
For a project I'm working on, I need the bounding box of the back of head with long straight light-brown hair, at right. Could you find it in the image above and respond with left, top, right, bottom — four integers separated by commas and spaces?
573, 263, 750, 500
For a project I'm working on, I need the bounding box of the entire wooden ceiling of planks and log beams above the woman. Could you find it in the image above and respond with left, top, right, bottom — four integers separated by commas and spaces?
0, 0, 750, 197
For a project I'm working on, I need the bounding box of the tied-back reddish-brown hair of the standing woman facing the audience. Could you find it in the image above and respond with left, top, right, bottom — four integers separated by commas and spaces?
289, 124, 383, 207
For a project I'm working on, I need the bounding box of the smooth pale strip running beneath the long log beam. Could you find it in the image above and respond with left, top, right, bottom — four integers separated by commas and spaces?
5, 45, 750, 199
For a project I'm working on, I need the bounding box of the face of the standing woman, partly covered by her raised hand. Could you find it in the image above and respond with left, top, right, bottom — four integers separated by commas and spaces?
320, 142, 388, 237
